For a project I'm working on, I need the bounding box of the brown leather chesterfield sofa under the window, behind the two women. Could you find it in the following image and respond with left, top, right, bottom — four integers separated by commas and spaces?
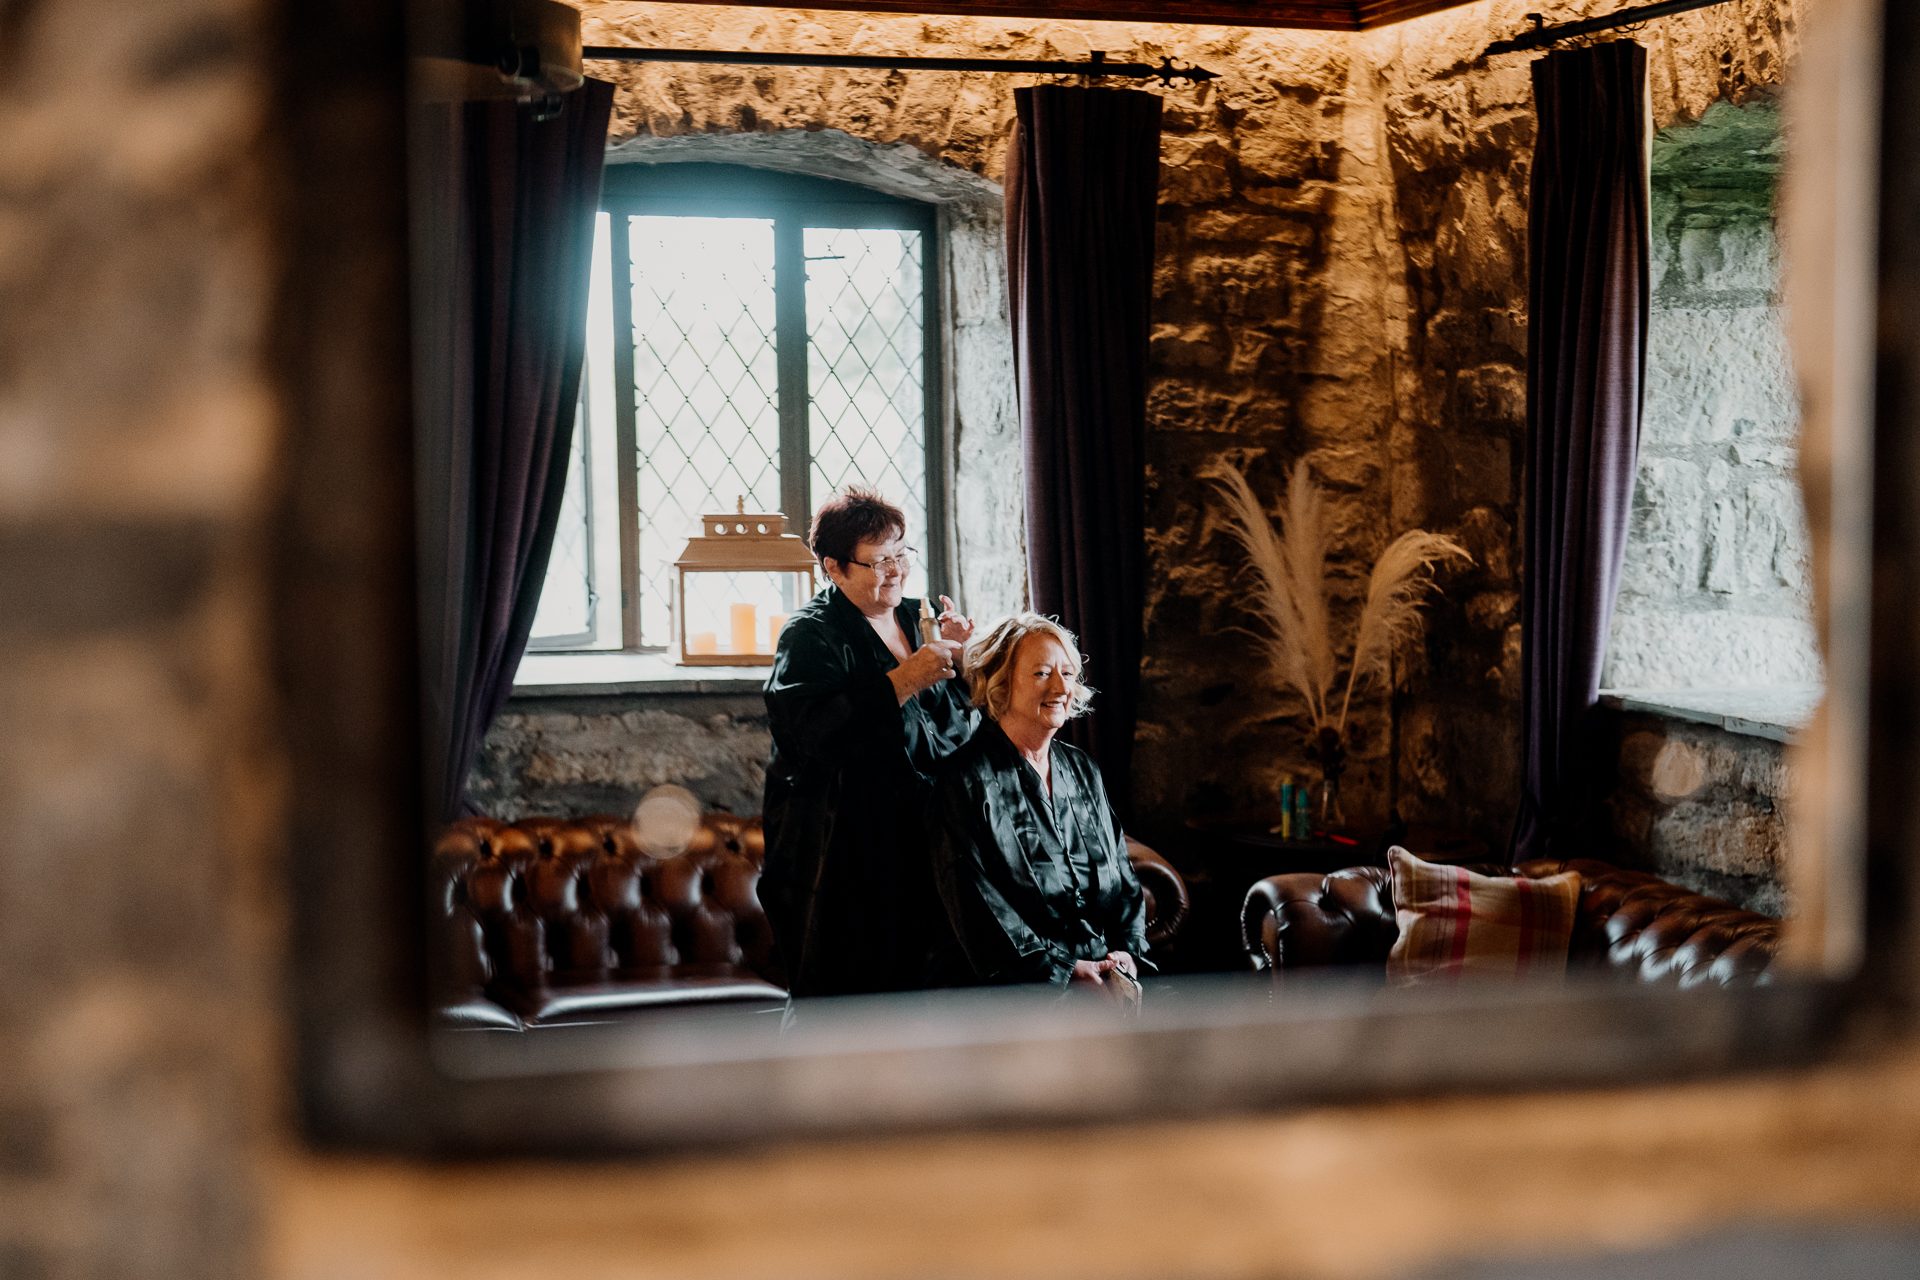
430, 812, 1188, 1031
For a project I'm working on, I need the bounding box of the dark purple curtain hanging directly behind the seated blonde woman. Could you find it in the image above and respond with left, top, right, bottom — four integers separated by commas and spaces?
1006, 84, 1160, 812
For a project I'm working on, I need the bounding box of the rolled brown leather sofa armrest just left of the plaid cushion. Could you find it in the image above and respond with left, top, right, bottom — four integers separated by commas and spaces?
1240, 867, 1400, 973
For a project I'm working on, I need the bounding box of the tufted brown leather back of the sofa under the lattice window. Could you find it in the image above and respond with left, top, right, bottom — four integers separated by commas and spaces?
432, 814, 783, 996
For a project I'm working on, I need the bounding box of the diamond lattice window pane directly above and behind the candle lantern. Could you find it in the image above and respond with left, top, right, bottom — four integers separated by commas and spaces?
628, 215, 780, 645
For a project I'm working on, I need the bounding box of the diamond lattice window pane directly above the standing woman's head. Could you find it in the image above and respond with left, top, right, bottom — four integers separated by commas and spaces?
804, 226, 929, 595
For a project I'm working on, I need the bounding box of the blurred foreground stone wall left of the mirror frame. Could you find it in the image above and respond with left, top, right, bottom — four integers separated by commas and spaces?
0, 0, 286, 1280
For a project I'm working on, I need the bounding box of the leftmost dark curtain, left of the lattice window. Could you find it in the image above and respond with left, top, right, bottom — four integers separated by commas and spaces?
413, 81, 612, 819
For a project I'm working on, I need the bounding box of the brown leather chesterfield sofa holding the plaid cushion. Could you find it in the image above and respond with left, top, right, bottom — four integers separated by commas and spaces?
1240, 858, 1782, 988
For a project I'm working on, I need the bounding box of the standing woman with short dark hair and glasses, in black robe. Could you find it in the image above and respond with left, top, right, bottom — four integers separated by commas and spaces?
760, 486, 977, 996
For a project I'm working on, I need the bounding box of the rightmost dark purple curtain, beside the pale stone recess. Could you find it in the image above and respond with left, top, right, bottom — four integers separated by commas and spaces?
1511, 40, 1651, 862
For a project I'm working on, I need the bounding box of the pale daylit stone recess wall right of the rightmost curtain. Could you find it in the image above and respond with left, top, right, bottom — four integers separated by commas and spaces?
1601, 98, 1820, 689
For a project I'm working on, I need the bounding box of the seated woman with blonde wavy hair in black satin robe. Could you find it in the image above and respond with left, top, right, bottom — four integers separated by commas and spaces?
927, 614, 1146, 986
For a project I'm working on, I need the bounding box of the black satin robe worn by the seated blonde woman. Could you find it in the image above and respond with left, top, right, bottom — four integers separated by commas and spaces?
927, 723, 1150, 984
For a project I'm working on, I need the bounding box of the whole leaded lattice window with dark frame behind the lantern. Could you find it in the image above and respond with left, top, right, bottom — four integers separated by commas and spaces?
534, 163, 947, 649
